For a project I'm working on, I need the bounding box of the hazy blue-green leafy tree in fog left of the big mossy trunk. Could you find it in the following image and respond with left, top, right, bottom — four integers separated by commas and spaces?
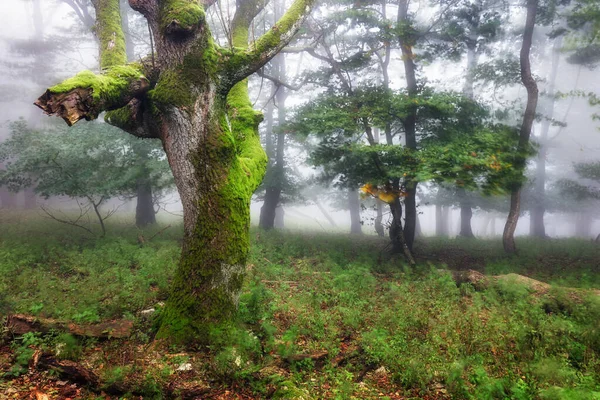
0, 120, 173, 235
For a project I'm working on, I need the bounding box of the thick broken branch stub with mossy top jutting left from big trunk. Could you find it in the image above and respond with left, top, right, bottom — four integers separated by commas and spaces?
34, 64, 150, 126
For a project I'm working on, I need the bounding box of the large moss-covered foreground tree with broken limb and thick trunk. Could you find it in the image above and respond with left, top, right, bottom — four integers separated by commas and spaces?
36, 0, 313, 343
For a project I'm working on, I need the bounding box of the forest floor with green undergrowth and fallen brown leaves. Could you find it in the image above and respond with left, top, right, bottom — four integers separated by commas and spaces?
0, 213, 600, 400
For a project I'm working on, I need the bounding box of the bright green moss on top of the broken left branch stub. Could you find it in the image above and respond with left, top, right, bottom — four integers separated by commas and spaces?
48, 64, 146, 108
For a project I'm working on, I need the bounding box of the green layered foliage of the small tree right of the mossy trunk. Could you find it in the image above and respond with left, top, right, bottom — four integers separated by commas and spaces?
292, 88, 518, 193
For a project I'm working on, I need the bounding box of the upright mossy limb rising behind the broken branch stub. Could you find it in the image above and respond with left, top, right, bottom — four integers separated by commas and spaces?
96, 0, 127, 69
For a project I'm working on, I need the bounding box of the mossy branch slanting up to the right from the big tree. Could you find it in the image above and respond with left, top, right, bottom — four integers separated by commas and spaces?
228, 0, 315, 84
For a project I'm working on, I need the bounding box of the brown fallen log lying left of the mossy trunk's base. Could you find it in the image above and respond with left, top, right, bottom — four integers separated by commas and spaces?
6, 314, 133, 339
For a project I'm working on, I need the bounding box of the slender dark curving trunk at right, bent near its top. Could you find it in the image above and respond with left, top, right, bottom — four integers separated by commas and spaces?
502, 0, 538, 253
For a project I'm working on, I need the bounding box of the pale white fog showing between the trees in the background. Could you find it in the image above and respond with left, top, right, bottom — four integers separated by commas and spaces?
0, 0, 600, 238
